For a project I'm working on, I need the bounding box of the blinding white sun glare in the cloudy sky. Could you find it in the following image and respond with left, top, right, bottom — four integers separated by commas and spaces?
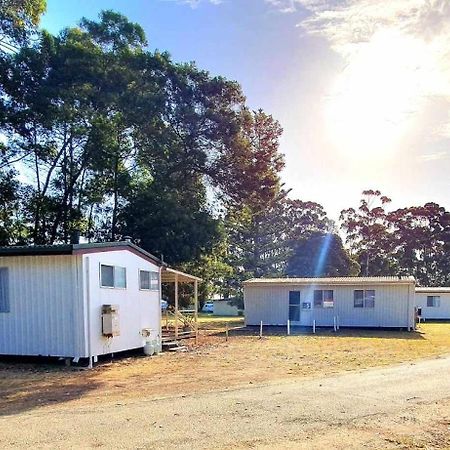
325, 31, 429, 160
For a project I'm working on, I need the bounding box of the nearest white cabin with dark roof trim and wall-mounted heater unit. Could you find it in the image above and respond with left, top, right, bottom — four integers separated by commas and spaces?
0, 242, 199, 361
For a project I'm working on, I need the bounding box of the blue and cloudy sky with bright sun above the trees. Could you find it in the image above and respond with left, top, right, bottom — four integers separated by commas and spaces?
42, 0, 450, 220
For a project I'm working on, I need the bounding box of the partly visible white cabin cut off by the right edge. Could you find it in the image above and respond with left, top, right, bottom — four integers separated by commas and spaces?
416, 287, 450, 320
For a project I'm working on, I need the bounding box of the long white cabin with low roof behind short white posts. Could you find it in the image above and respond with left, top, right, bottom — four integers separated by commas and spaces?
244, 277, 415, 329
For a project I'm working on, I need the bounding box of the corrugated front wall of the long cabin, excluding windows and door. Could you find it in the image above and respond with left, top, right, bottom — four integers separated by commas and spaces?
244, 284, 414, 327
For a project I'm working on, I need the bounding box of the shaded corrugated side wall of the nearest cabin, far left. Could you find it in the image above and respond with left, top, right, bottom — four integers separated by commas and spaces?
0, 255, 83, 357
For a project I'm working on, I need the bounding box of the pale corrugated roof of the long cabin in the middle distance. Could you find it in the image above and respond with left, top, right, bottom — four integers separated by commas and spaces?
244, 277, 415, 285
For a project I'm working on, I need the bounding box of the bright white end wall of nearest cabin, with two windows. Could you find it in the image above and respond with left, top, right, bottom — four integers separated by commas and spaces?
83, 250, 161, 356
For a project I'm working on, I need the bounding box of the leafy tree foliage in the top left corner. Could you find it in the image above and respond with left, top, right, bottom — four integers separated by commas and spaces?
0, 0, 47, 52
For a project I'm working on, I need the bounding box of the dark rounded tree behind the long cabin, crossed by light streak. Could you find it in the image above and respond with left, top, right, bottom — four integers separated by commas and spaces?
286, 232, 360, 277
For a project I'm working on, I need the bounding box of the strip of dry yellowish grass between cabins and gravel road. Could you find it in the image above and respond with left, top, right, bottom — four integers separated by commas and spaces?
0, 318, 450, 414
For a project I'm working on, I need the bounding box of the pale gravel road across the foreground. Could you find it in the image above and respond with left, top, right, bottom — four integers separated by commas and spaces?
0, 357, 450, 449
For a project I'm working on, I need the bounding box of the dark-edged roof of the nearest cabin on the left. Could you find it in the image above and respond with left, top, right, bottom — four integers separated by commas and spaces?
0, 241, 165, 266
